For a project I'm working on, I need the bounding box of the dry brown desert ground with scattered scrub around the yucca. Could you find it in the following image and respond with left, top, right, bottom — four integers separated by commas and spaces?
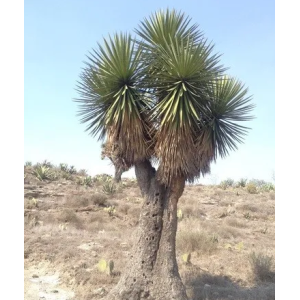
24, 162, 275, 300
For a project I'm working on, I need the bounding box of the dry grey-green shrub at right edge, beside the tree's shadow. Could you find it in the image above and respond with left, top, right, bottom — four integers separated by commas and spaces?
249, 252, 274, 282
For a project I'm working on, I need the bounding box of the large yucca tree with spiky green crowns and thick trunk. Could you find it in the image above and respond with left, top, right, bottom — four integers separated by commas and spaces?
76, 10, 253, 300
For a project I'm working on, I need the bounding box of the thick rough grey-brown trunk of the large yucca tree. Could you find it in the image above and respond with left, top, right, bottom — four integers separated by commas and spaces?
105, 161, 188, 300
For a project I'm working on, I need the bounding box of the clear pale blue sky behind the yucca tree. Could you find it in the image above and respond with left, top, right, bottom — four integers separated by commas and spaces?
24, 0, 275, 183
